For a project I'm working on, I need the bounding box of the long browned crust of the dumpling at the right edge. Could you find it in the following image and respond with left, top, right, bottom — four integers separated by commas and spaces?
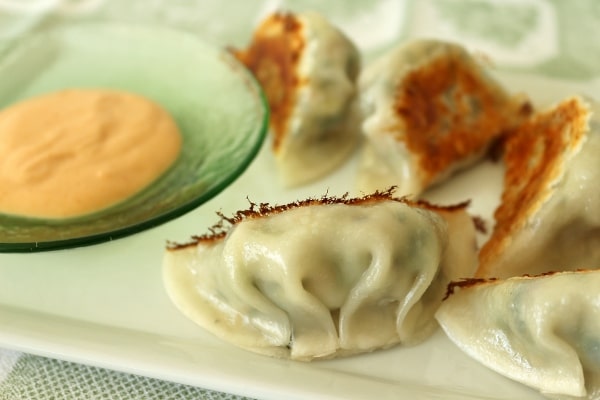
476, 97, 589, 276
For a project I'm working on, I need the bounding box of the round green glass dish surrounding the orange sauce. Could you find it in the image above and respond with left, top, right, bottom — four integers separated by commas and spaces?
0, 23, 268, 252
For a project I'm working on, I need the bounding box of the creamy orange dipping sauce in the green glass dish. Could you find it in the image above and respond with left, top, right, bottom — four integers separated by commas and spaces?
0, 89, 182, 219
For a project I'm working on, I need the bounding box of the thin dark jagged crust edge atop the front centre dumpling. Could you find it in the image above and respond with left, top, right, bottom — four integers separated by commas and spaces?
167, 187, 469, 250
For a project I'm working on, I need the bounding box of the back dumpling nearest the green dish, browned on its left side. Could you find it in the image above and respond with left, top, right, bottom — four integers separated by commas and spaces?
235, 12, 360, 186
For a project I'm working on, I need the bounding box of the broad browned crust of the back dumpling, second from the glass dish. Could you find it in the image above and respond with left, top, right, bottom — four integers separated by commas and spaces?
394, 46, 532, 184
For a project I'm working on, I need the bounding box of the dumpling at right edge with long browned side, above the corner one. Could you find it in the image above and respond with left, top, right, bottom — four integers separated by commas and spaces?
476, 97, 600, 278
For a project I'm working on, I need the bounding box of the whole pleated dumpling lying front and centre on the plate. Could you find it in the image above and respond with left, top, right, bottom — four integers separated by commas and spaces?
163, 191, 477, 360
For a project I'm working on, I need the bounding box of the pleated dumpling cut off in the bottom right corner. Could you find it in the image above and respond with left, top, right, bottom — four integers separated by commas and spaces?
436, 270, 600, 400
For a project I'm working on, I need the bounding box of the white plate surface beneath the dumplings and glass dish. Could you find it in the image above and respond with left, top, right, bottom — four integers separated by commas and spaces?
0, 75, 592, 400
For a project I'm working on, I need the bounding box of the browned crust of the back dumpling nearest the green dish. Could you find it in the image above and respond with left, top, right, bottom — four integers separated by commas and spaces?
233, 13, 306, 152
